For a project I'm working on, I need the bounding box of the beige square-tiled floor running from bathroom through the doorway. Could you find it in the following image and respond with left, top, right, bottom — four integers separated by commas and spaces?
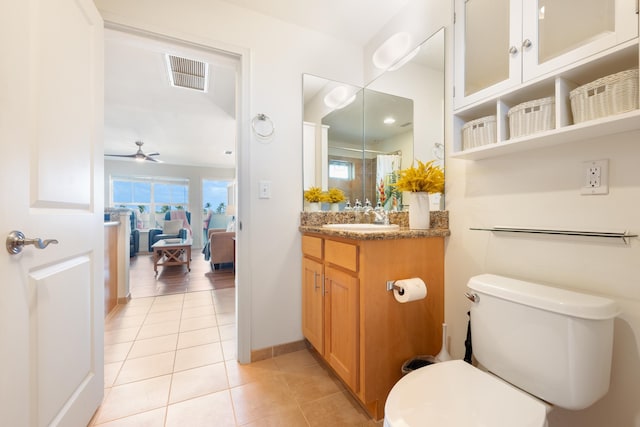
90, 288, 382, 427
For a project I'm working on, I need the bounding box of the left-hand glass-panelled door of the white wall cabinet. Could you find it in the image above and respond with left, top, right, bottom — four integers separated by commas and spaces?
454, 0, 522, 108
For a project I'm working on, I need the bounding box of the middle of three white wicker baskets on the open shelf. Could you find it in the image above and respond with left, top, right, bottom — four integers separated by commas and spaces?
507, 96, 556, 138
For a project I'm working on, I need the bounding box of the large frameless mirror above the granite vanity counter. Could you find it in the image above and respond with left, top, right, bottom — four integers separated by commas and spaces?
303, 29, 444, 210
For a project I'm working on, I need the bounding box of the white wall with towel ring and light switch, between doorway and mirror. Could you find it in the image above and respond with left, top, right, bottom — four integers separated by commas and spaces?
96, 0, 362, 351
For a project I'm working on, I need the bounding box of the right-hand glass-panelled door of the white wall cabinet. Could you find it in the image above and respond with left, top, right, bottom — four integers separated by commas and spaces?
522, 0, 638, 81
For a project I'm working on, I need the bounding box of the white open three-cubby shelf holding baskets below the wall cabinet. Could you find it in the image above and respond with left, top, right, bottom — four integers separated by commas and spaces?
450, 38, 640, 160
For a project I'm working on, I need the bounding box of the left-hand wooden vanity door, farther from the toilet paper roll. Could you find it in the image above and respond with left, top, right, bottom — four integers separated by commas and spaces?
302, 257, 324, 354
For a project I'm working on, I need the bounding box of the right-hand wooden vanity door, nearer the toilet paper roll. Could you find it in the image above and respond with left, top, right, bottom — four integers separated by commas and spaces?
324, 267, 359, 392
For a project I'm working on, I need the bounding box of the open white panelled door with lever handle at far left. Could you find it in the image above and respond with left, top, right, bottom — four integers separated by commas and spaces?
0, 0, 104, 427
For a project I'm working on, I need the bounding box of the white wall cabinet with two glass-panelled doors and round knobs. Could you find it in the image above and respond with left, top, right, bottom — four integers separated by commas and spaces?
454, 0, 638, 109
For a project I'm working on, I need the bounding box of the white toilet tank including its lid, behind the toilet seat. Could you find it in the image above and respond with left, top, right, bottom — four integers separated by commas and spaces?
467, 274, 618, 410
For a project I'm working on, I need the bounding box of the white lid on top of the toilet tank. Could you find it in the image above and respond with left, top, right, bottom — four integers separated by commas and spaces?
467, 274, 619, 319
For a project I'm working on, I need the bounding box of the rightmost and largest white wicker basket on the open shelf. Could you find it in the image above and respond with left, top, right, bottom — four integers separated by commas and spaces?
569, 69, 638, 123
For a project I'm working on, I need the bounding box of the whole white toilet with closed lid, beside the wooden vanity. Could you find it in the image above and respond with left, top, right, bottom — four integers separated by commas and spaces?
384, 274, 619, 427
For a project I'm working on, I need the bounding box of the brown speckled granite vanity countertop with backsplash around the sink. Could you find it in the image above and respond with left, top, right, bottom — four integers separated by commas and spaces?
298, 211, 451, 240
